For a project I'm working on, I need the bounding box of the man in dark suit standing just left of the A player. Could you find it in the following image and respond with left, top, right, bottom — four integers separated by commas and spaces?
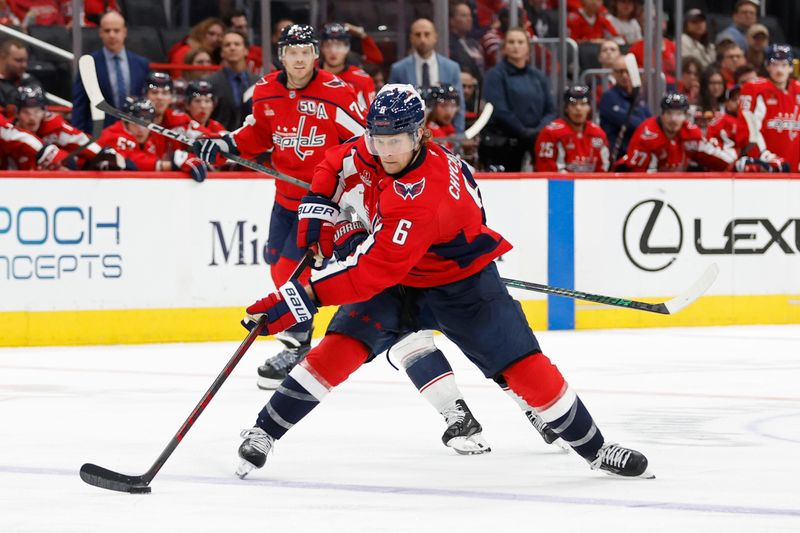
208, 31, 258, 131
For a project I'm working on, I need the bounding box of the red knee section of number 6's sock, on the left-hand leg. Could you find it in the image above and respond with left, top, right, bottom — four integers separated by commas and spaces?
303, 333, 369, 389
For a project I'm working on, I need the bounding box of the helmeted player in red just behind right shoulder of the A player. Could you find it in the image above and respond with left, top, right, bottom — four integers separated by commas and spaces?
319, 22, 375, 111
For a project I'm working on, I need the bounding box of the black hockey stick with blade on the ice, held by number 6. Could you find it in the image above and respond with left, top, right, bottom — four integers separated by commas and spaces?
80, 253, 313, 494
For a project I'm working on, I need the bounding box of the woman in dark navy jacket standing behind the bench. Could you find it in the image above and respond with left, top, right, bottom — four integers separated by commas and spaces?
478, 28, 556, 172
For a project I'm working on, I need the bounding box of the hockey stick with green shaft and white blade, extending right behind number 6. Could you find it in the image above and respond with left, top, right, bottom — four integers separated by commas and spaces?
500, 263, 719, 315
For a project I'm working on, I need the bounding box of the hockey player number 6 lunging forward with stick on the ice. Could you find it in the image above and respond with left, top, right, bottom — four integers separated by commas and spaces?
237, 85, 653, 477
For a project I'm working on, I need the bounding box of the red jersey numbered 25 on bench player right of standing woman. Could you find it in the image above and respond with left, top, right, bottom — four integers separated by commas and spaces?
535, 118, 609, 172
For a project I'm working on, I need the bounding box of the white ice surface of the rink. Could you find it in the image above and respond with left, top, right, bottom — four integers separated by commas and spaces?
0, 326, 800, 533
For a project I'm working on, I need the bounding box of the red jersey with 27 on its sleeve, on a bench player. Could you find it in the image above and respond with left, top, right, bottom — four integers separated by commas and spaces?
619, 117, 736, 172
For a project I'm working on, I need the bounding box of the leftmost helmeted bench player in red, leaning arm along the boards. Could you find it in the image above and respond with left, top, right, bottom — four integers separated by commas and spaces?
15, 85, 125, 170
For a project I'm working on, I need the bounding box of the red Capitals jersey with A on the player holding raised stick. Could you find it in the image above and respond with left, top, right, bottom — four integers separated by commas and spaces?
233, 70, 364, 210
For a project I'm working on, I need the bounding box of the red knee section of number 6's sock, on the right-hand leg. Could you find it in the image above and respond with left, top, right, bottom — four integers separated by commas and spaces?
503, 353, 566, 410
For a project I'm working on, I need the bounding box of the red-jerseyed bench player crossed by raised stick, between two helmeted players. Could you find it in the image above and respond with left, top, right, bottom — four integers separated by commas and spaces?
143, 72, 197, 158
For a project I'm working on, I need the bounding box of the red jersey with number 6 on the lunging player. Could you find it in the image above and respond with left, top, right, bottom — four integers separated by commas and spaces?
311, 137, 511, 305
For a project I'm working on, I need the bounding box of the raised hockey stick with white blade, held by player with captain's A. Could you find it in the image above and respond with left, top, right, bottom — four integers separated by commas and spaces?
78, 55, 311, 189
